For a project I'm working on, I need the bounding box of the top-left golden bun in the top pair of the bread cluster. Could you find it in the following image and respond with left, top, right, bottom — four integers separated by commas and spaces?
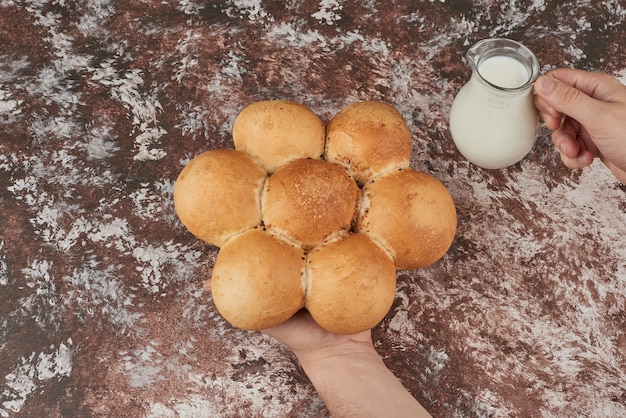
233, 100, 325, 174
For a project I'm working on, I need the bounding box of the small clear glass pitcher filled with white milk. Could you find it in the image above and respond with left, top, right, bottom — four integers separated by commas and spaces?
450, 38, 539, 169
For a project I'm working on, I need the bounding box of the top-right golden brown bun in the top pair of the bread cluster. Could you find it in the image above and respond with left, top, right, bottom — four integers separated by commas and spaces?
325, 101, 413, 185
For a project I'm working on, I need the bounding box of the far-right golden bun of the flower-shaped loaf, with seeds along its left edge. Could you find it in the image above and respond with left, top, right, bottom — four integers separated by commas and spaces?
357, 169, 456, 270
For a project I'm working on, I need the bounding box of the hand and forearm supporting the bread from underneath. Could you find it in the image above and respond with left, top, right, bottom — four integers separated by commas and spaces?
204, 279, 430, 418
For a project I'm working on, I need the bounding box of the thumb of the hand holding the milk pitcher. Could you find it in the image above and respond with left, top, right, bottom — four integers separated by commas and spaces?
535, 75, 604, 130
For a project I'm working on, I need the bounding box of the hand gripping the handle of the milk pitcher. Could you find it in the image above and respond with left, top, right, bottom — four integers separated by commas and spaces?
534, 68, 626, 184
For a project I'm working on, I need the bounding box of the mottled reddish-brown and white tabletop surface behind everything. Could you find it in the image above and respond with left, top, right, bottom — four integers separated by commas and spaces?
0, 0, 626, 417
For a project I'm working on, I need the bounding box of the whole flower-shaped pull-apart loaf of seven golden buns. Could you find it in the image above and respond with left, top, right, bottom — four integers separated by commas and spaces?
174, 100, 457, 334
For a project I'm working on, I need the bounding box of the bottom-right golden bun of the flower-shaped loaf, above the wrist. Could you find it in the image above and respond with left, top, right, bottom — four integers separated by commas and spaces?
305, 234, 396, 334
